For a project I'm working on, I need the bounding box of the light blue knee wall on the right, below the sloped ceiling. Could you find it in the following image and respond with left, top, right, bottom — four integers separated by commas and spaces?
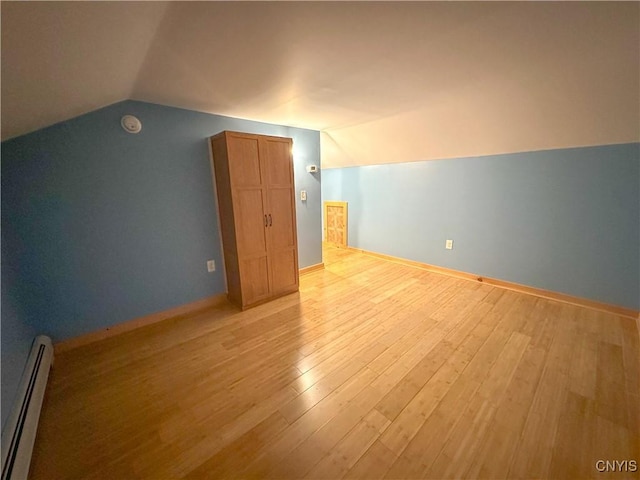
322, 143, 640, 310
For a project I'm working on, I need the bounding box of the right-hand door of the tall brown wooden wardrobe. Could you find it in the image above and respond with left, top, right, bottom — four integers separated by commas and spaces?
260, 137, 298, 295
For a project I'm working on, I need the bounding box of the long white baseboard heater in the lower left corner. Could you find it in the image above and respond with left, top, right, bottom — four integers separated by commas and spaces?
2, 335, 53, 480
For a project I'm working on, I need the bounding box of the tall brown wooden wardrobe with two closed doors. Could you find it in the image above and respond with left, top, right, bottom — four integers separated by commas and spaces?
211, 131, 298, 309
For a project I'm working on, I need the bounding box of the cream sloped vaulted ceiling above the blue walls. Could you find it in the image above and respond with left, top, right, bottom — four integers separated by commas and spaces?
1, 2, 640, 167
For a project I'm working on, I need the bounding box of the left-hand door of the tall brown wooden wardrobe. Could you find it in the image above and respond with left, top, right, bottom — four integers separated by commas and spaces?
227, 134, 270, 306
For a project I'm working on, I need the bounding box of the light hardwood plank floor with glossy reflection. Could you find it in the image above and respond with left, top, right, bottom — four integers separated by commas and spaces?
31, 248, 640, 479
